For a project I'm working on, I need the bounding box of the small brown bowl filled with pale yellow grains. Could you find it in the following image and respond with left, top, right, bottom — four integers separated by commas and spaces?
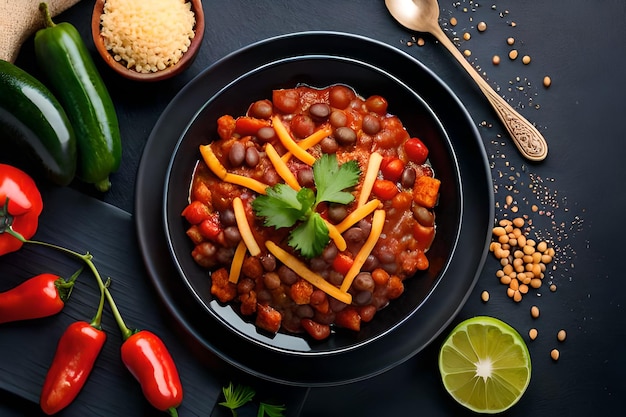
91, 0, 204, 81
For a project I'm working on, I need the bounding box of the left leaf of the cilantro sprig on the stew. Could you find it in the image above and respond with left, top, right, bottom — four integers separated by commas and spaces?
252, 183, 308, 228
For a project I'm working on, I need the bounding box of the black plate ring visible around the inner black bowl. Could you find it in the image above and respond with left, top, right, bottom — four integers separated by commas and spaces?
135, 32, 493, 385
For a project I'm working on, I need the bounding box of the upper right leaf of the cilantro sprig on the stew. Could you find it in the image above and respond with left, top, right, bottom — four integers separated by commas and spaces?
313, 154, 361, 204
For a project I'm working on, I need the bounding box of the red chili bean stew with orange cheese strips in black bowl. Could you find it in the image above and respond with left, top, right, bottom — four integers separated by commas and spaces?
182, 84, 440, 340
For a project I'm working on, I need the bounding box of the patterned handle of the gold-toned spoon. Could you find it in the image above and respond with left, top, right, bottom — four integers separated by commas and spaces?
431, 25, 548, 161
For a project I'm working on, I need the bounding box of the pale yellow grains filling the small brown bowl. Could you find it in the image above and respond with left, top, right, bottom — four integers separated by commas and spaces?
100, 0, 195, 73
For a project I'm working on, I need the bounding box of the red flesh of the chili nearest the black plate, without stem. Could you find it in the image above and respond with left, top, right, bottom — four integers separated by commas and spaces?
122, 330, 183, 415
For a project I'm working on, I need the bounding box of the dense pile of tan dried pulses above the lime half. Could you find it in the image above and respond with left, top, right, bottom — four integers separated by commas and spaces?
489, 217, 555, 302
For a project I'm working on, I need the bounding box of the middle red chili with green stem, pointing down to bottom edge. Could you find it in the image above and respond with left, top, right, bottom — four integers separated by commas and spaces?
39, 281, 108, 415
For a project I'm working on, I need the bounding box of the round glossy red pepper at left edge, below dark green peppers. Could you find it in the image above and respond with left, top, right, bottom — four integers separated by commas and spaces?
0, 164, 43, 255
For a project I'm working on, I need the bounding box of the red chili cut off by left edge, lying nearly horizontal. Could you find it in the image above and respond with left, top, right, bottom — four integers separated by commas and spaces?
0, 269, 82, 324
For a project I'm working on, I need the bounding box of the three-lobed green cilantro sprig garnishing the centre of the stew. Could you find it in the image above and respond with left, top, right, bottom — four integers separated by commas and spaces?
252, 154, 361, 258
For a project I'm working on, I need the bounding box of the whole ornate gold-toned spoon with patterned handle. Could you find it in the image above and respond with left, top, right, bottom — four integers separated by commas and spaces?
385, 0, 548, 161
